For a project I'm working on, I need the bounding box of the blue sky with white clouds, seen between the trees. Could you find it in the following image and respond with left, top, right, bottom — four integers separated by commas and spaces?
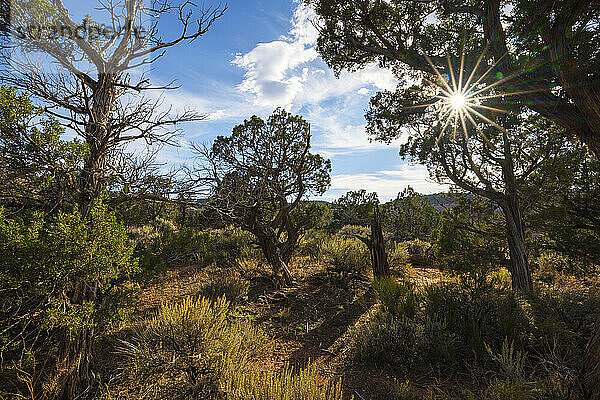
65, 0, 447, 200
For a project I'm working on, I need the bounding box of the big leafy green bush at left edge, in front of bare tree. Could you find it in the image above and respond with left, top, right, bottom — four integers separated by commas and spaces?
0, 202, 138, 358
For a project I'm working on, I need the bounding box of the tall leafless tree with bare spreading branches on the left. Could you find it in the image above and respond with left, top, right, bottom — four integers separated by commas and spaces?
0, 0, 226, 398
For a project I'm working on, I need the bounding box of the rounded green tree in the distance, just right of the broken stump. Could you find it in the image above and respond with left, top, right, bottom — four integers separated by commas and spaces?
383, 186, 439, 242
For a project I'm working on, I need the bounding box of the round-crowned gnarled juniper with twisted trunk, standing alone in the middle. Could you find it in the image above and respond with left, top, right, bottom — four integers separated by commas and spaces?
196, 108, 331, 283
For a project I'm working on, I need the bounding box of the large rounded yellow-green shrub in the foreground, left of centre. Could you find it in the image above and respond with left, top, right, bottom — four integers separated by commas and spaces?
115, 298, 269, 399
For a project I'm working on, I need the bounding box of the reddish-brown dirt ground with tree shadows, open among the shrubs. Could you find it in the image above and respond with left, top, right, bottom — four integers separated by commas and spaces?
129, 260, 442, 400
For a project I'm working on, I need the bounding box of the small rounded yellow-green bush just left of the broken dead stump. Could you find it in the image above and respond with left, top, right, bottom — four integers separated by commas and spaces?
322, 236, 371, 273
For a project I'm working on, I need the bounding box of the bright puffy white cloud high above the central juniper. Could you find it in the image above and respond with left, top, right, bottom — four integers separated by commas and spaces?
233, 3, 397, 109
